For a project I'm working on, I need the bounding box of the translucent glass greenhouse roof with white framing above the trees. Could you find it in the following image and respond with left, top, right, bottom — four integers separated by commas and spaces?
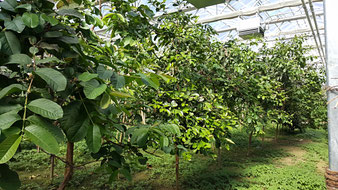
97, 0, 325, 63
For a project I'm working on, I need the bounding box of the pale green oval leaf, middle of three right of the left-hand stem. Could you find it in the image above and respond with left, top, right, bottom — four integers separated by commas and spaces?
27, 98, 63, 119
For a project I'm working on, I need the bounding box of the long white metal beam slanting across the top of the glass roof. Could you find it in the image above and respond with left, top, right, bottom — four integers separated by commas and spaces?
197, 0, 323, 23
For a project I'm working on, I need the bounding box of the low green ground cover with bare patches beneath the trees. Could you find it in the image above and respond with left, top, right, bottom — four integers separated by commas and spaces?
10, 129, 328, 190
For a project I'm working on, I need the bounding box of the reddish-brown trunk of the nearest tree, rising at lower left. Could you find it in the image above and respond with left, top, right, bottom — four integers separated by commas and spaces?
58, 142, 74, 190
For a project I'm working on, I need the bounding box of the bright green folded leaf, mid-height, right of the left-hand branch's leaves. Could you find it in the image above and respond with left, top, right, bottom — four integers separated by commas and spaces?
80, 79, 107, 99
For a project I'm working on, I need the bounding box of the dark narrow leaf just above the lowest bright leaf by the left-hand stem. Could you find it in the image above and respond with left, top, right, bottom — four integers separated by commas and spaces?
27, 115, 65, 143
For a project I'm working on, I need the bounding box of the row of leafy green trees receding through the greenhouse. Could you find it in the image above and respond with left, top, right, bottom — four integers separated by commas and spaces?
0, 0, 325, 189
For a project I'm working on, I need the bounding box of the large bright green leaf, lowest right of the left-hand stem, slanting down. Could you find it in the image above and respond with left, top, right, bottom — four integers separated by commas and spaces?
25, 124, 60, 154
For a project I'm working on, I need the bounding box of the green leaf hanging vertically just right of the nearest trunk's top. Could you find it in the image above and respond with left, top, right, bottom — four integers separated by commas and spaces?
86, 124, 101, 153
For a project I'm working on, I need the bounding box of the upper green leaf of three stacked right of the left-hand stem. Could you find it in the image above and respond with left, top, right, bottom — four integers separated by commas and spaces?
35, 68, 67, 92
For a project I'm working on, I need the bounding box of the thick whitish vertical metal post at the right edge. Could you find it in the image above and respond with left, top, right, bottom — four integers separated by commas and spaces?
324, 0, 338, 172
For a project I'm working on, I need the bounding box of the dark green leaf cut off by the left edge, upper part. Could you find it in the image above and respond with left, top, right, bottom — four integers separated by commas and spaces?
0, 31, 21, 55
